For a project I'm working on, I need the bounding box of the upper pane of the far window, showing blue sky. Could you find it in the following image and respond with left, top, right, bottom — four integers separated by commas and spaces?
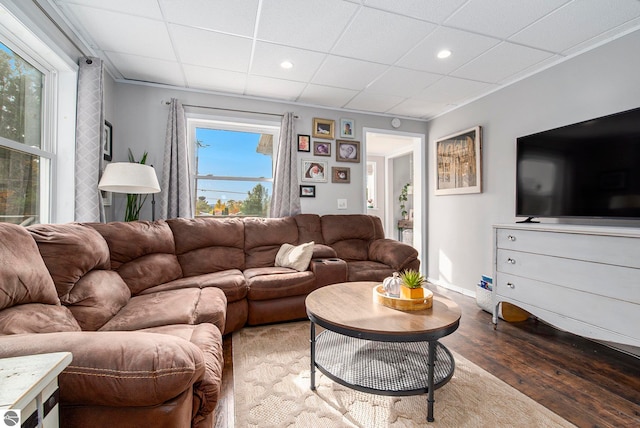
196, 128, 273, 178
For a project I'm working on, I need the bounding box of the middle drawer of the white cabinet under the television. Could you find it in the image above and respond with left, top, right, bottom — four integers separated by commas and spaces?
496, 249, 640, 305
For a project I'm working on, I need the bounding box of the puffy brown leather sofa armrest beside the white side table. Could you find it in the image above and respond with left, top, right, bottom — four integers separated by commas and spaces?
0, 332, 205, 407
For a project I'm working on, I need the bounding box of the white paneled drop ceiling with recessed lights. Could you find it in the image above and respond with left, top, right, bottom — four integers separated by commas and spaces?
48, 0, 640, 119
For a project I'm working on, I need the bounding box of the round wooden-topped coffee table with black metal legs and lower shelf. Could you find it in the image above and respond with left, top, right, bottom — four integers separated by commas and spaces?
305, 282, 461, 422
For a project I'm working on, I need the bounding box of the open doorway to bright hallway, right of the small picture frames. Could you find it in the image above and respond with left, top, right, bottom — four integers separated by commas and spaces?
363, 128, 427, 268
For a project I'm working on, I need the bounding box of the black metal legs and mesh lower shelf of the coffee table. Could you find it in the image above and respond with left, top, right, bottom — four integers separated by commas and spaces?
311, 322, 455, 422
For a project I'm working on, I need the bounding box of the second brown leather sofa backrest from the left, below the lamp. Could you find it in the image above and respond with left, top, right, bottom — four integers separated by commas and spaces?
27, 223, 131, 331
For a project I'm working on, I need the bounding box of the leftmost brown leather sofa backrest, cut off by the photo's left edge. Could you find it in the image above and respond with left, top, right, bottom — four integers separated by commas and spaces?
0, 223, 80, 334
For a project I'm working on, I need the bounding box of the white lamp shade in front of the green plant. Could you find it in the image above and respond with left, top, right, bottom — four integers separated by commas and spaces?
98, 162, 160, 194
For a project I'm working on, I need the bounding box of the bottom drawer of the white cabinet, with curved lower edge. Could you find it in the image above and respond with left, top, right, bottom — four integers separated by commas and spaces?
495, 273, 640, 341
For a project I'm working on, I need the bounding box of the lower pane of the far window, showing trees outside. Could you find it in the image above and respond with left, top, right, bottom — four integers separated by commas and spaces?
195, 179, 272, 217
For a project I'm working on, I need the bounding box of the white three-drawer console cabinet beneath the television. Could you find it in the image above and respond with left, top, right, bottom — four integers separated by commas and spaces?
493, 224, 640, 347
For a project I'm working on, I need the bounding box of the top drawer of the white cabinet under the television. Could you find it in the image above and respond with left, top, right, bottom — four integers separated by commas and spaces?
496, 228, 640, 269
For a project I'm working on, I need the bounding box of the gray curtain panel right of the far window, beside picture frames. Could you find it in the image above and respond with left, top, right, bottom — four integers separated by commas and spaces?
269, 113, 300, 217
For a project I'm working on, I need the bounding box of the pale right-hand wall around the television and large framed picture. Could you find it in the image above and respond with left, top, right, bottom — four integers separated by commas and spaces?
424, 31, 640, 294
